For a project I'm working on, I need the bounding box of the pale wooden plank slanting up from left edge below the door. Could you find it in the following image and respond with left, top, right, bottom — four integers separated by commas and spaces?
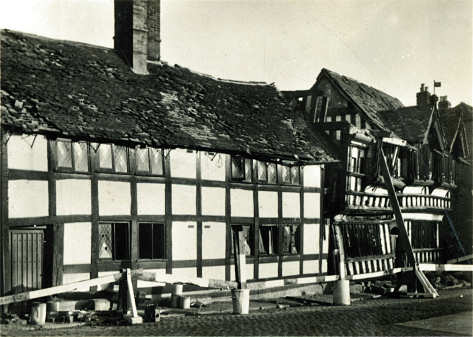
0, 273, 122, 305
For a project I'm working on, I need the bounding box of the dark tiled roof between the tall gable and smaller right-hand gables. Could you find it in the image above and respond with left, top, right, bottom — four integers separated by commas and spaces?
377, 106, 432, 144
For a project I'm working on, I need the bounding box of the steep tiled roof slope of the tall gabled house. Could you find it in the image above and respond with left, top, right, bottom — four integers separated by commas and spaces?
319, 68, 403, 130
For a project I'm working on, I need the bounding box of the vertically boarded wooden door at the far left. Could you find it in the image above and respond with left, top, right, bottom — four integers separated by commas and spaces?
9, 229, 44, 293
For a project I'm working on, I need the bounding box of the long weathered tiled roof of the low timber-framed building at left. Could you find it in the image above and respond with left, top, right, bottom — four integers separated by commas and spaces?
1, 30, 336, 163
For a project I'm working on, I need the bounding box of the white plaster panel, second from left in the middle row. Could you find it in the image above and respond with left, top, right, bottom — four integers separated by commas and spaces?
56, 179, 91, 215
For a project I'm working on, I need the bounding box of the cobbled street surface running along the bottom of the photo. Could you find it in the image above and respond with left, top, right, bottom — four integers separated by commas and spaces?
0, 289, 473, 336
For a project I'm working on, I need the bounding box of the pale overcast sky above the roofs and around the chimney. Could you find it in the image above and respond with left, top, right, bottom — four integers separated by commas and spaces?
0, 0, 473, 105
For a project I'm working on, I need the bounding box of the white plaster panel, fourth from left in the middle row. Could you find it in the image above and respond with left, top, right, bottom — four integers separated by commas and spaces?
136, 183, 165, 215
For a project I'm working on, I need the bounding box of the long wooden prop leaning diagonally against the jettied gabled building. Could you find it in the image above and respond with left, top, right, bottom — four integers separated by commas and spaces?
379, 146, 438, 297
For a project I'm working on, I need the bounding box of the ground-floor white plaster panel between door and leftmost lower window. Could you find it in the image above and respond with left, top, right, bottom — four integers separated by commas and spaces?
63, 222, 92, 265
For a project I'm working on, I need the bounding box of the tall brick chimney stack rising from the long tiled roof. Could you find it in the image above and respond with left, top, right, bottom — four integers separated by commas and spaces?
114, 0, 161, 74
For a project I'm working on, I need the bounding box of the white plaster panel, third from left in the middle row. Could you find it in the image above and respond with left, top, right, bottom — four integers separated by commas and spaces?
98, 180, 131, 215
